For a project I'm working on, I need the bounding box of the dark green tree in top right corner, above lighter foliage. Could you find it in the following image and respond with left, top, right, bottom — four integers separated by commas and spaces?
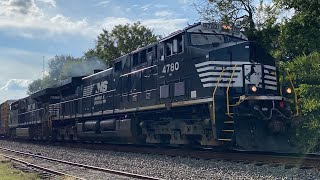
275, 0, 320, 60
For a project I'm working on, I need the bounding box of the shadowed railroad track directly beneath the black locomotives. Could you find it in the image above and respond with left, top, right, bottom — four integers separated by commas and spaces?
0, 139, 320, 169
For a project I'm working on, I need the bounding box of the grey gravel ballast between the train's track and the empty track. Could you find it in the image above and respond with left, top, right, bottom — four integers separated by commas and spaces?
0, 140, 320, 180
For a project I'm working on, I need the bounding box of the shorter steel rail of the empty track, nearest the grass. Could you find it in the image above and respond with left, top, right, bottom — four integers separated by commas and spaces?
0, 154, 85, 180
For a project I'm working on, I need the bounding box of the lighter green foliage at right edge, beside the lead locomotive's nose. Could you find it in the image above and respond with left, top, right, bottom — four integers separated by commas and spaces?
284, 52, 320, 152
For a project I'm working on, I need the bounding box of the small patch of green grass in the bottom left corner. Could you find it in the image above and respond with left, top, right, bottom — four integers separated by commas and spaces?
0, 156, 40, 180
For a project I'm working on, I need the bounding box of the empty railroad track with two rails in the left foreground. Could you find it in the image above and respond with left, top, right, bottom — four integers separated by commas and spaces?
0, 147, 161, 180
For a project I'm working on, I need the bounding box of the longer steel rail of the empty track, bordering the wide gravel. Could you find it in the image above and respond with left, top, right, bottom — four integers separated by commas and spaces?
0, 147, 163, 180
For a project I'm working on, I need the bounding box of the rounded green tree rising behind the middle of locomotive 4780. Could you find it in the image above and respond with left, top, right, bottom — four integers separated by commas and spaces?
85, 22, 157, 65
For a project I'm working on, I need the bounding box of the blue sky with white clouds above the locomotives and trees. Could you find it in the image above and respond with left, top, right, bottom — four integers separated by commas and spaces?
0, 0, 199, 103
